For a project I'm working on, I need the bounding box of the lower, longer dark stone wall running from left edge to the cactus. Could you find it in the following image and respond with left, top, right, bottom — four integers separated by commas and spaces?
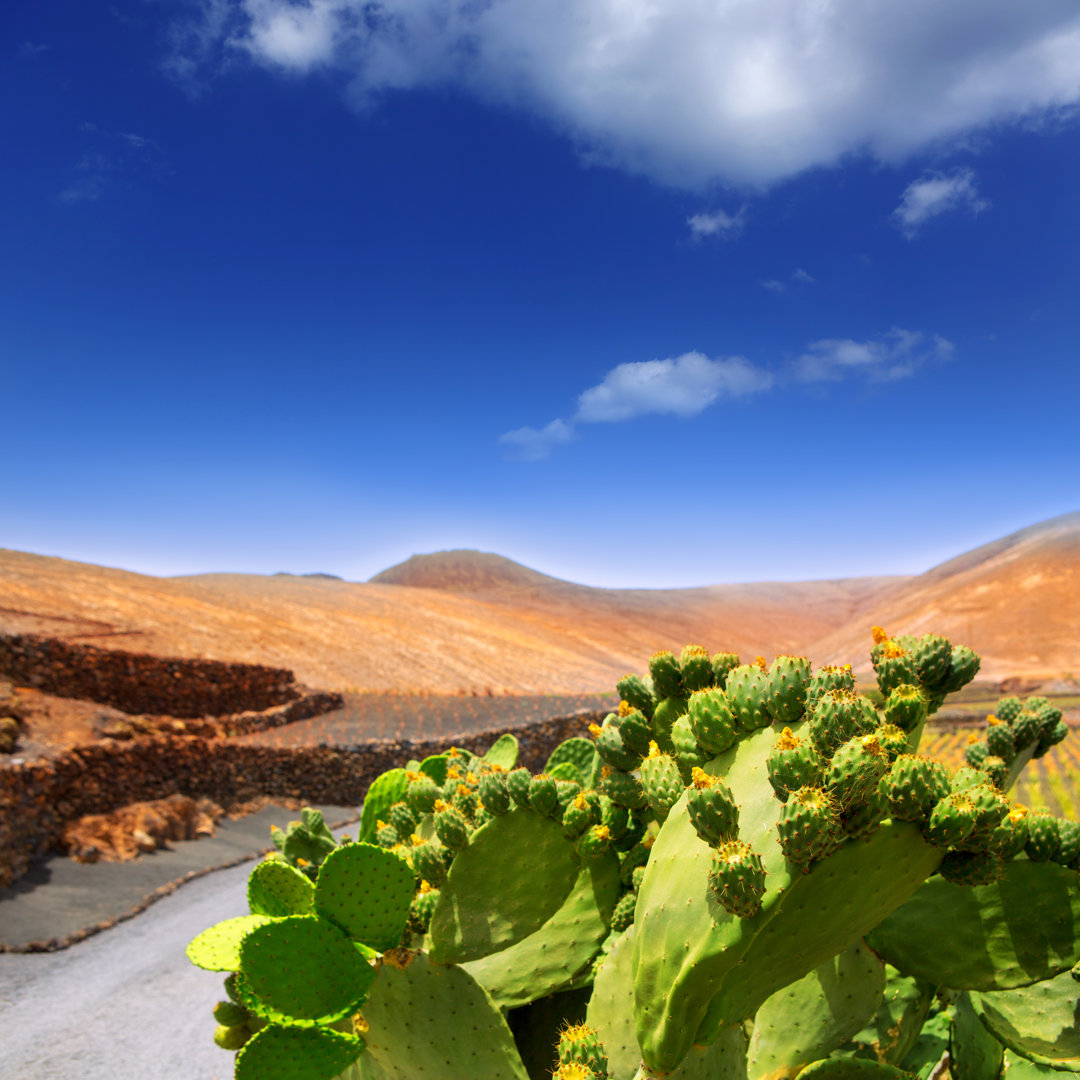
0, 713, 604, 885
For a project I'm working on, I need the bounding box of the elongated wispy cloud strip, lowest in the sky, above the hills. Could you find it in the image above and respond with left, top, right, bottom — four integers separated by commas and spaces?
499, 327, 954, 461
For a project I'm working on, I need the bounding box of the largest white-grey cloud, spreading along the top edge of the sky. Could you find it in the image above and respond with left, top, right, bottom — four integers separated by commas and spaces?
173, 0, 1080, 188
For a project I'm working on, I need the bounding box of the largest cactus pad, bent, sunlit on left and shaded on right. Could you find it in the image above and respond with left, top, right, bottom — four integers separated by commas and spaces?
634, 725, 942, 1071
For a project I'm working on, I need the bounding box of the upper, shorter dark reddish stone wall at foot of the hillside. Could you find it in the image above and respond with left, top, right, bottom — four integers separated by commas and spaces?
0, 634, 298, 719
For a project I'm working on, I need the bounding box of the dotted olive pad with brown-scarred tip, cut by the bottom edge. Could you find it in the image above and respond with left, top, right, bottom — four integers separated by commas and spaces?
360, 950, 528, 1080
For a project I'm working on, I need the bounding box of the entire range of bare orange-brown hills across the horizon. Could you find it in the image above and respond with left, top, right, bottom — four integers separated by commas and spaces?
0, 513, 1080, 693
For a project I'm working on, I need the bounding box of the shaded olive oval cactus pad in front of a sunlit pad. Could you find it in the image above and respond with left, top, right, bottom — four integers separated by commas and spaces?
430, 808, 580, 963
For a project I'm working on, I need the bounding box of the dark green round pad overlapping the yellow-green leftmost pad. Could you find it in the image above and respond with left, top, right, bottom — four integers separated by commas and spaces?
240, 915, 375, 1023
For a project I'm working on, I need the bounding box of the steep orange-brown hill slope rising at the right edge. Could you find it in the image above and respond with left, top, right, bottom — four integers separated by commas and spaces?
810, 512, 1080, 679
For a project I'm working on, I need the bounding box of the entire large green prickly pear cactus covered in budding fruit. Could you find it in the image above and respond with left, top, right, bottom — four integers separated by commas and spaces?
188, 627, 1080, 1080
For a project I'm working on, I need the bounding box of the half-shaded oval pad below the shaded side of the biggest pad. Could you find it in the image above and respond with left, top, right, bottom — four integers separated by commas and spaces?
746, 941, 886, 1080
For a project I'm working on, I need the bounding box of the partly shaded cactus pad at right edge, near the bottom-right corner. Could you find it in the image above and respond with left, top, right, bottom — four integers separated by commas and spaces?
971, 971, 1080, 1072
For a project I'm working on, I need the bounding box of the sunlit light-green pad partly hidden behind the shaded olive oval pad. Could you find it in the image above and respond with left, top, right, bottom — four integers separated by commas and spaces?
461, 854, 620, 1009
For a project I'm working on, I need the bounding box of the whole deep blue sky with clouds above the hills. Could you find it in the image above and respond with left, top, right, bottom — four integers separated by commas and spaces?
0, 0, 1080, 586
